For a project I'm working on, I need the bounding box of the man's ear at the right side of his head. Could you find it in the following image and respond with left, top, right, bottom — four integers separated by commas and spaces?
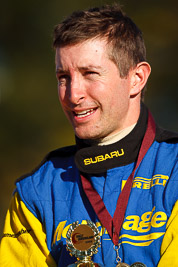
130, 62, 151, 96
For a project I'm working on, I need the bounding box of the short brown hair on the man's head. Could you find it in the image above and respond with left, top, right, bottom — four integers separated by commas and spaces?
53, 4, 146, 78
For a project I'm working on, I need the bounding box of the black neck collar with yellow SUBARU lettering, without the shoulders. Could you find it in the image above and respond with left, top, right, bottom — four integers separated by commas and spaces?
75, 104, 148, 173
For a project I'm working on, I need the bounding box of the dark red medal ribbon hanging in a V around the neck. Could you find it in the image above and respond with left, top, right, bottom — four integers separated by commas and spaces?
80, 112, 156, 246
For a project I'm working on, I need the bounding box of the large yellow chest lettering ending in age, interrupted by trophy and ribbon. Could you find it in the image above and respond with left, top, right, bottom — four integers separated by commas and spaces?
53, 207, 167, 246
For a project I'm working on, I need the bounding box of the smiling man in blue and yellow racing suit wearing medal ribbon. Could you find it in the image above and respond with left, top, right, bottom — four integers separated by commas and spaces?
0, 5, 178, 267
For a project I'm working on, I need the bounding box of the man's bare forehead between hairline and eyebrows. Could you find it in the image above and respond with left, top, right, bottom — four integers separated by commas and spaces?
56, 39, 109, 67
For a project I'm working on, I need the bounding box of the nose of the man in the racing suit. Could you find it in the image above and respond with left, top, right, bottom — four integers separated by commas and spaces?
68, 74, 85, 104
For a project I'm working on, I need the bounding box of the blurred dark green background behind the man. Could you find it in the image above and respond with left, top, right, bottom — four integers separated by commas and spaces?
0, 0, 178, 233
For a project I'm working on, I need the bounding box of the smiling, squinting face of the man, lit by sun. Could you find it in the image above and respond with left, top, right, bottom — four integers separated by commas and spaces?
56, 39, 135, 139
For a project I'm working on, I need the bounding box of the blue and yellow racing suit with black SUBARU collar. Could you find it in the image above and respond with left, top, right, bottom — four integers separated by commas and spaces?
0, 105, 178, 267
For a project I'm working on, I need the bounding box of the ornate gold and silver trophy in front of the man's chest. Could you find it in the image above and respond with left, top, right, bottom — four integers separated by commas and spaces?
66, 220, 101, 267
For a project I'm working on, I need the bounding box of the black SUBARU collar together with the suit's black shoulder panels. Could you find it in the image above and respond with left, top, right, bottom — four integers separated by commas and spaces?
18, 103, 178, 185
